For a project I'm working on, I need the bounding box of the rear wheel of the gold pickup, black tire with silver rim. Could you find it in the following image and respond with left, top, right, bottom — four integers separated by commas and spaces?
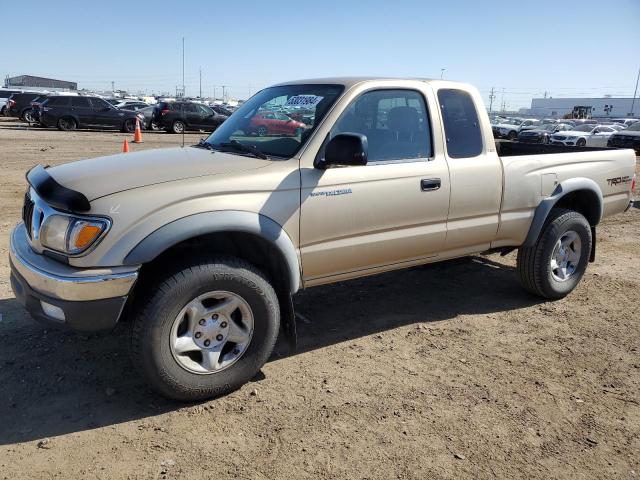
516, 208, 592, 300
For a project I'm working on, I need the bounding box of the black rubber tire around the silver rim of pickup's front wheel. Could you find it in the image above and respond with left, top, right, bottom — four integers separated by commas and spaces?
131, 258, 280, 401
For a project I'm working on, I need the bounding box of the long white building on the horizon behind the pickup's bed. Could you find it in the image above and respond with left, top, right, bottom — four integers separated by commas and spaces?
530, 97, 640, 118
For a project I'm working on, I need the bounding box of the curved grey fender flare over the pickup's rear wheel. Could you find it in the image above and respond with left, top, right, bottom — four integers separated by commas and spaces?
523, 177, 604, 247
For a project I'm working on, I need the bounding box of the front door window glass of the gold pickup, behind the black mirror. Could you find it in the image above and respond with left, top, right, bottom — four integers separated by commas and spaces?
331, 90, 433, 163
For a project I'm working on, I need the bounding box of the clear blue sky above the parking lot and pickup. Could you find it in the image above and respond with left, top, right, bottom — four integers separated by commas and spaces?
0, 0, 640, 108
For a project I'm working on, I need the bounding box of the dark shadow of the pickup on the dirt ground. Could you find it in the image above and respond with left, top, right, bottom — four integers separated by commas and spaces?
0, 257, 540, 445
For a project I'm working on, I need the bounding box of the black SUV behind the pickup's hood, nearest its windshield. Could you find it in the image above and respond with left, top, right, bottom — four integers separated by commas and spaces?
153, 102, 229, 133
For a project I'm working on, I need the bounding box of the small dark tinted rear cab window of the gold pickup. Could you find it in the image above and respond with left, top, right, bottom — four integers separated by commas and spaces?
438, 88, 483, 158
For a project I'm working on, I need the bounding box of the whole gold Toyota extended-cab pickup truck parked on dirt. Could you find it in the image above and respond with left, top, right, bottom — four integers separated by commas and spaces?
10, 78, 636, 400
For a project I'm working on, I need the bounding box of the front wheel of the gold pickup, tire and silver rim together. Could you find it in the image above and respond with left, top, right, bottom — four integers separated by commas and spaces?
131, 258, 280, 401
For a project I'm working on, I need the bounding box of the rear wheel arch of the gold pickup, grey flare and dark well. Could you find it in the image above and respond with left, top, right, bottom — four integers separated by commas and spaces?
523, 178, 604, 247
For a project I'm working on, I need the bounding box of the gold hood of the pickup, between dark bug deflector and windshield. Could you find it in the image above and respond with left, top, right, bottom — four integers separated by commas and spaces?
47, 147, 272, 201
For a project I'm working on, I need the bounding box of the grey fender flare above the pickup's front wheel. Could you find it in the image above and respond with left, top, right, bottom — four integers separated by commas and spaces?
124, 210, 302, 294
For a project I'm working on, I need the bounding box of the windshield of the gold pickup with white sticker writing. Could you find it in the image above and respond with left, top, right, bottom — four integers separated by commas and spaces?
206, 84, 344, 158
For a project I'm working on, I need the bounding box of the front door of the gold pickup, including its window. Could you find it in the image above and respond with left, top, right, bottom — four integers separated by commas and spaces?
300, 89, 450, 285
